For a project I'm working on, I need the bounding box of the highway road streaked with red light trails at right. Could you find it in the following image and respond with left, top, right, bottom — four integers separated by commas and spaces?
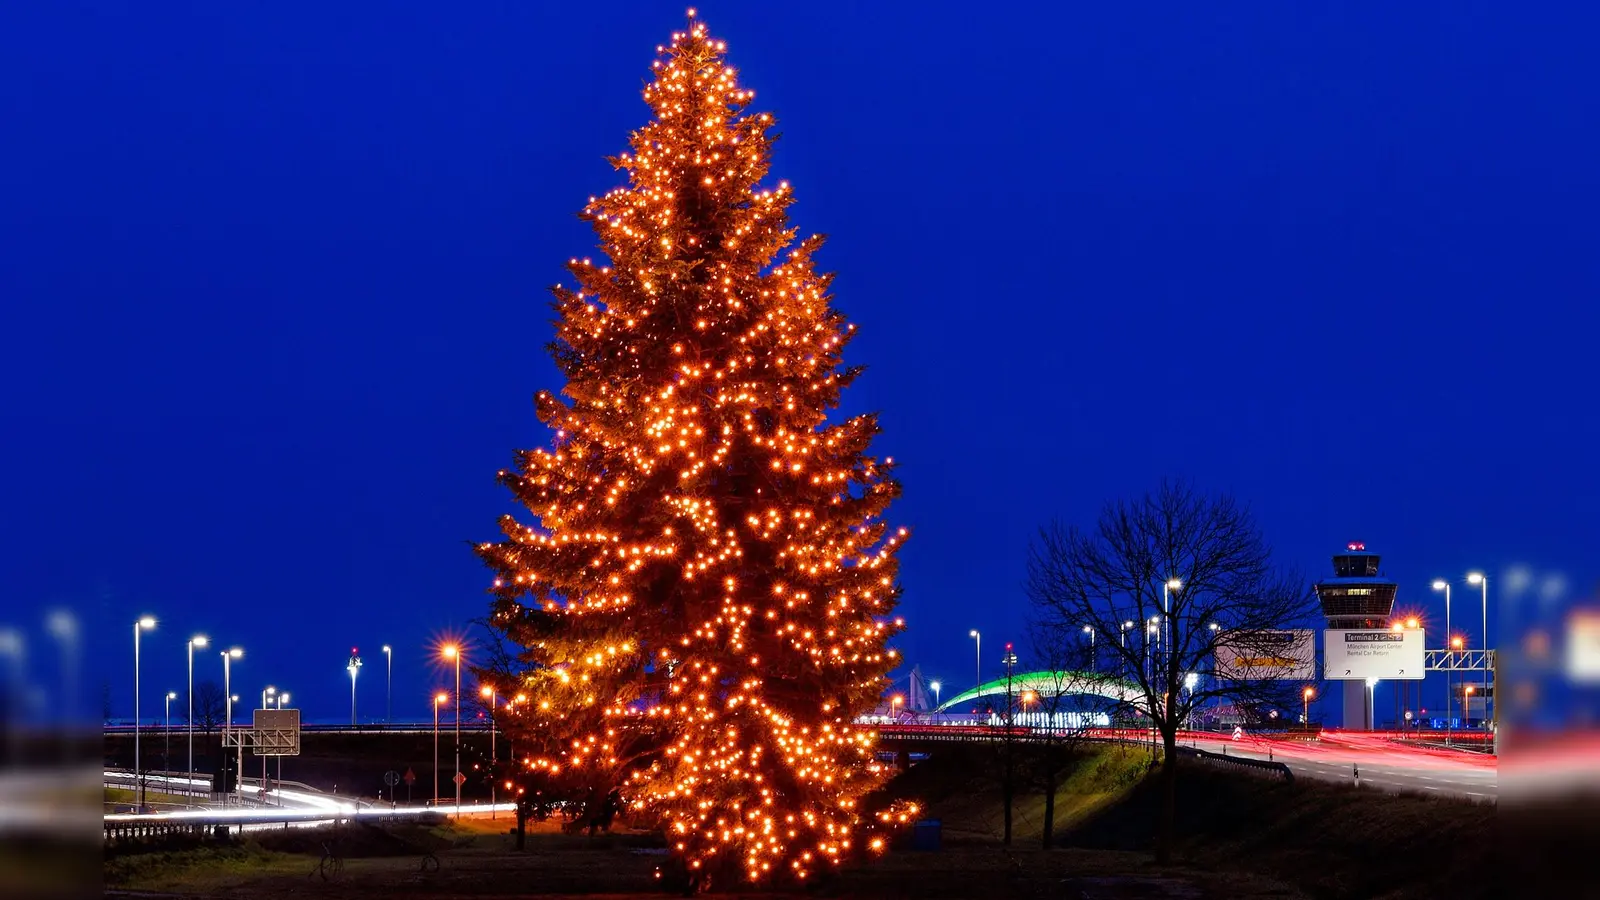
1184, 732, 1499, 802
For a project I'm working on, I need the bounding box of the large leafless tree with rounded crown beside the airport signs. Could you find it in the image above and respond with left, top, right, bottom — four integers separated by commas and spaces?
1027, 482, 1315, 862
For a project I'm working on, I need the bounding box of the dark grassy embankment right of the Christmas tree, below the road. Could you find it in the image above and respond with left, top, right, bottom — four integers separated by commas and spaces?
896, 748, 1494, 900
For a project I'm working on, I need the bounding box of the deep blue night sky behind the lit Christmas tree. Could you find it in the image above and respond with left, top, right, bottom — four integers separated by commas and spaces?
0, 0, 1600, 721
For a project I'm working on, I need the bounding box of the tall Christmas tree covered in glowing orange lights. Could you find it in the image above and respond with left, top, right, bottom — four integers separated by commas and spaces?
478, 11, 915, 879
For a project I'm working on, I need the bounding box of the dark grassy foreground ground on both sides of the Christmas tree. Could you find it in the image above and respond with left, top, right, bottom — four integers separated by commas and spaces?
106, 748, 1496, 900
